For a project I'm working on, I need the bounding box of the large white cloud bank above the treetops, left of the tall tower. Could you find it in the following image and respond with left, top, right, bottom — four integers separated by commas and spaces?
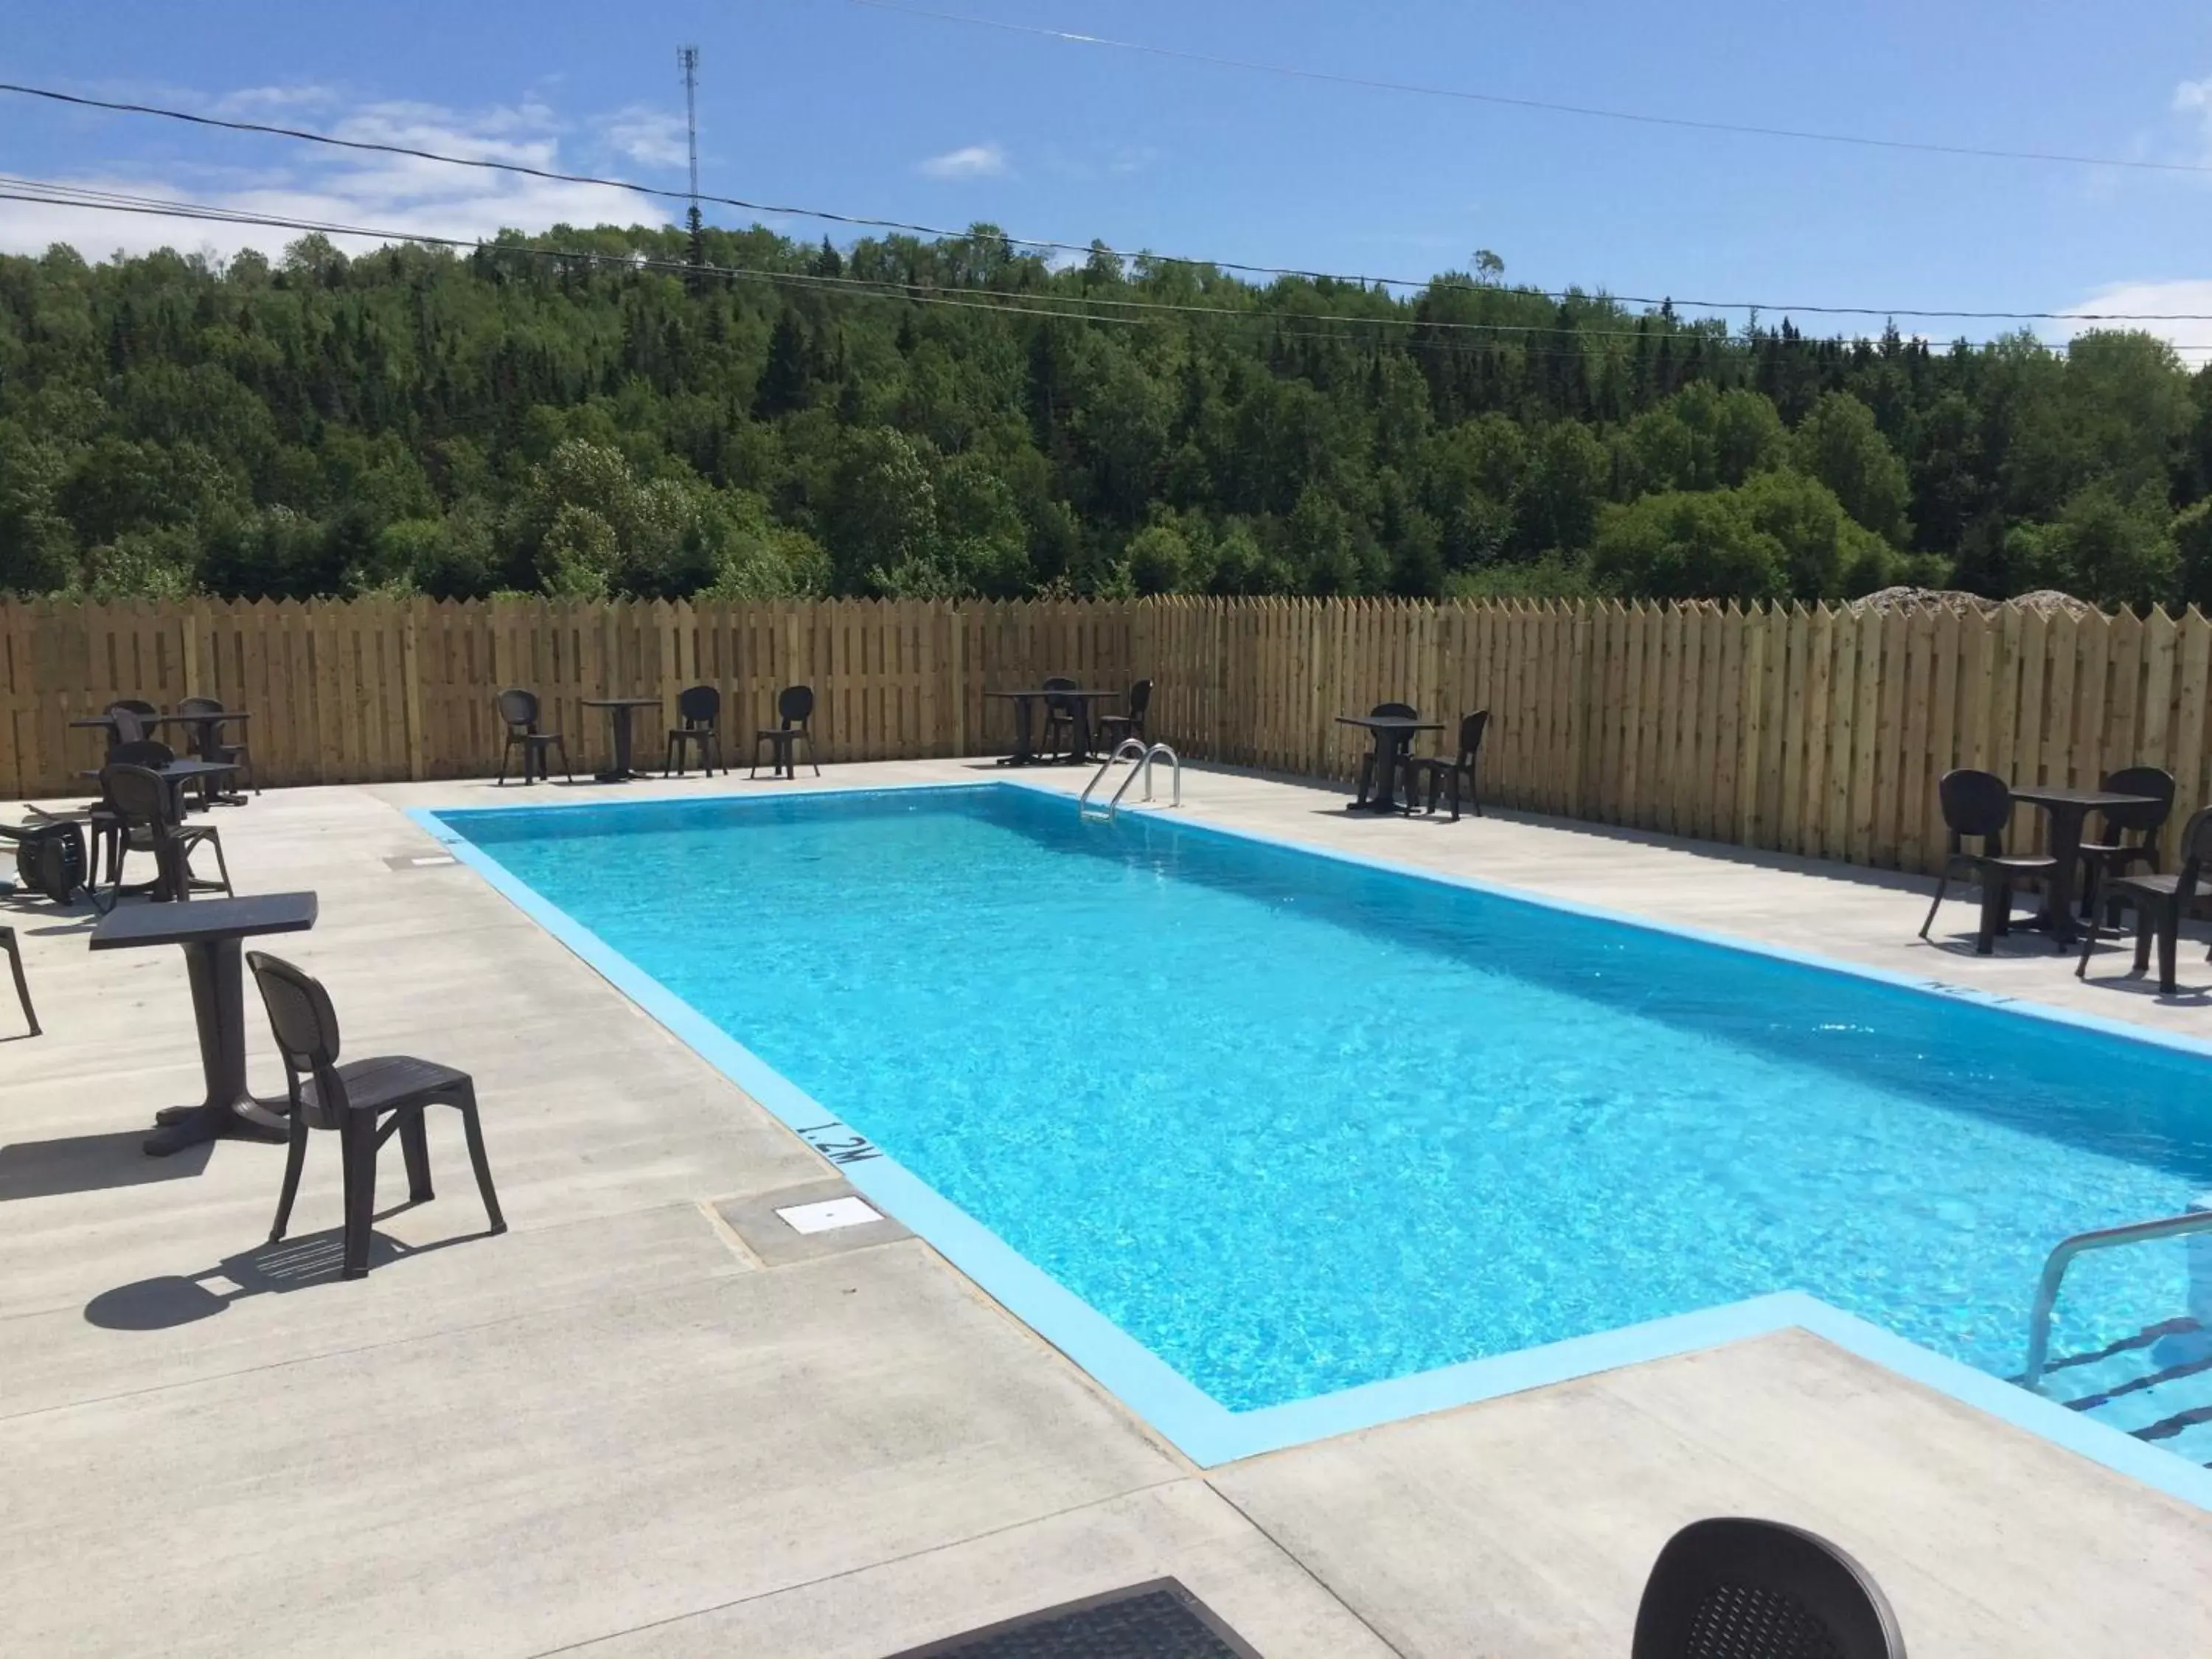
0, 86, 681, 259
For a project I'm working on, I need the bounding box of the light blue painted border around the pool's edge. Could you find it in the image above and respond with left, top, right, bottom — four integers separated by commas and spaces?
405, 779, 2212, 1511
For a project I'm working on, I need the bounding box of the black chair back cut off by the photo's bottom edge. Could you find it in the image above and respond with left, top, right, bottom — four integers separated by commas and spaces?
1630, 1517, 1905, 1659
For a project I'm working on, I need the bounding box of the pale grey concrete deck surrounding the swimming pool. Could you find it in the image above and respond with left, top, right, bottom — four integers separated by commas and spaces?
0, 761, 2212, 1659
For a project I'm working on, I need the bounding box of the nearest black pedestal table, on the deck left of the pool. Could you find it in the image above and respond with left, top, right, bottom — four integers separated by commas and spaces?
93, 894, 316, 1157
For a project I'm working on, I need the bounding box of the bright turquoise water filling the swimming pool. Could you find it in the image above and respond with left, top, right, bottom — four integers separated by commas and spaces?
440, 785, 2212, 1411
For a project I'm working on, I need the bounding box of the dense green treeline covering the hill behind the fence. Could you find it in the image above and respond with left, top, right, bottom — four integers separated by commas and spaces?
0, 226, 2212, 606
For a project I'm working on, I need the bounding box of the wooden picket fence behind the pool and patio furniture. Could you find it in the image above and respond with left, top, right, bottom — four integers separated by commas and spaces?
0, 599, 2212, 885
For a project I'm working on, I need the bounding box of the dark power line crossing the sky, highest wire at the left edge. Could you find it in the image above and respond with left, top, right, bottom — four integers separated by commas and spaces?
13, 77, 2212, 323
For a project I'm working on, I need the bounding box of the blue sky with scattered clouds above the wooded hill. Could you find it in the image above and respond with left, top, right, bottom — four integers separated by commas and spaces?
0, 0, 2212, 358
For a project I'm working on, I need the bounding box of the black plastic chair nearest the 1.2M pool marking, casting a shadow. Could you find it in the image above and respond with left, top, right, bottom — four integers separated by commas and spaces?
246, 951, 507, 1279
